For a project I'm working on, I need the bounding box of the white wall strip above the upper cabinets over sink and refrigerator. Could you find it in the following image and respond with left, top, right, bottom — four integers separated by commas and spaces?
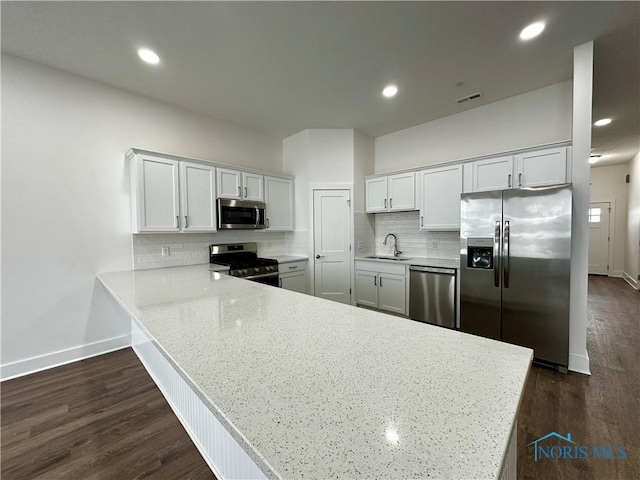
375, 81, 572, 173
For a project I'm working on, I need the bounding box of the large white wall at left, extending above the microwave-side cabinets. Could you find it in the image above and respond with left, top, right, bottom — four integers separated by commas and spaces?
1, 54, 282, 378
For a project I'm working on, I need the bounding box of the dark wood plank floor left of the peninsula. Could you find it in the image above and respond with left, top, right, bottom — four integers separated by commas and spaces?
0, 349, 215, 480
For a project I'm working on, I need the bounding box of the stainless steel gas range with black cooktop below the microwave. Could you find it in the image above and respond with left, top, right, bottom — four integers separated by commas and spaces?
209, 242, 278, 287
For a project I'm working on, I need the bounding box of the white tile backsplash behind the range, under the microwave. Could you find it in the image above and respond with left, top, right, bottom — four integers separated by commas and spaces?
132, 230, 309, 270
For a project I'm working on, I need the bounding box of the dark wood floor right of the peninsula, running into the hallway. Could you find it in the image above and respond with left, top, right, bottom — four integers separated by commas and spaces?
518, 276, 640, 480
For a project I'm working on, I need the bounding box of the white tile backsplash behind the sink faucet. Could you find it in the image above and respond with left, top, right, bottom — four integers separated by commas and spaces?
373, 211, 460, 258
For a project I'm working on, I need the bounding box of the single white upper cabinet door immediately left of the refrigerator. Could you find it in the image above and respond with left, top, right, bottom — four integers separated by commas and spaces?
420, 165, 462, 231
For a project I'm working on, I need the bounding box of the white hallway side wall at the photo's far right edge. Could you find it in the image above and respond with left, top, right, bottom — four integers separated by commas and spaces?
624, 152, 640, 290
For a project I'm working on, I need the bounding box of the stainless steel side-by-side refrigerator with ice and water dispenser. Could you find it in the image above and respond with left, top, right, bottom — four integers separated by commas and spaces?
460, 185, 571, 372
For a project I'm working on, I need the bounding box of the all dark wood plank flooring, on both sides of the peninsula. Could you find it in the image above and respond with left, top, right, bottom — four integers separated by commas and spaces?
1, 277, 640, 480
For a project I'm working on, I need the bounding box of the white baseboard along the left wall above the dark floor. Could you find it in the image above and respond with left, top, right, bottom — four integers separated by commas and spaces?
0, 334, 131, 382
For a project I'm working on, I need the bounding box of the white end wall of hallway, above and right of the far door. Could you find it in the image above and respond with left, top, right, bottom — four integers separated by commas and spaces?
589, 165, 629, 277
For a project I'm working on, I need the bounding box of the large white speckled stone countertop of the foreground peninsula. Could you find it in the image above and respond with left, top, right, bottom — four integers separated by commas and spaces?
98, 265, 532, 479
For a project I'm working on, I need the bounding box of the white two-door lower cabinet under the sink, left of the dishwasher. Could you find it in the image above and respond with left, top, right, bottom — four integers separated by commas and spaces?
355, 261, 409, 315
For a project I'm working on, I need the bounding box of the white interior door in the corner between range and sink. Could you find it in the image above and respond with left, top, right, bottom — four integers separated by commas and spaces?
313, 190, 351, 304
